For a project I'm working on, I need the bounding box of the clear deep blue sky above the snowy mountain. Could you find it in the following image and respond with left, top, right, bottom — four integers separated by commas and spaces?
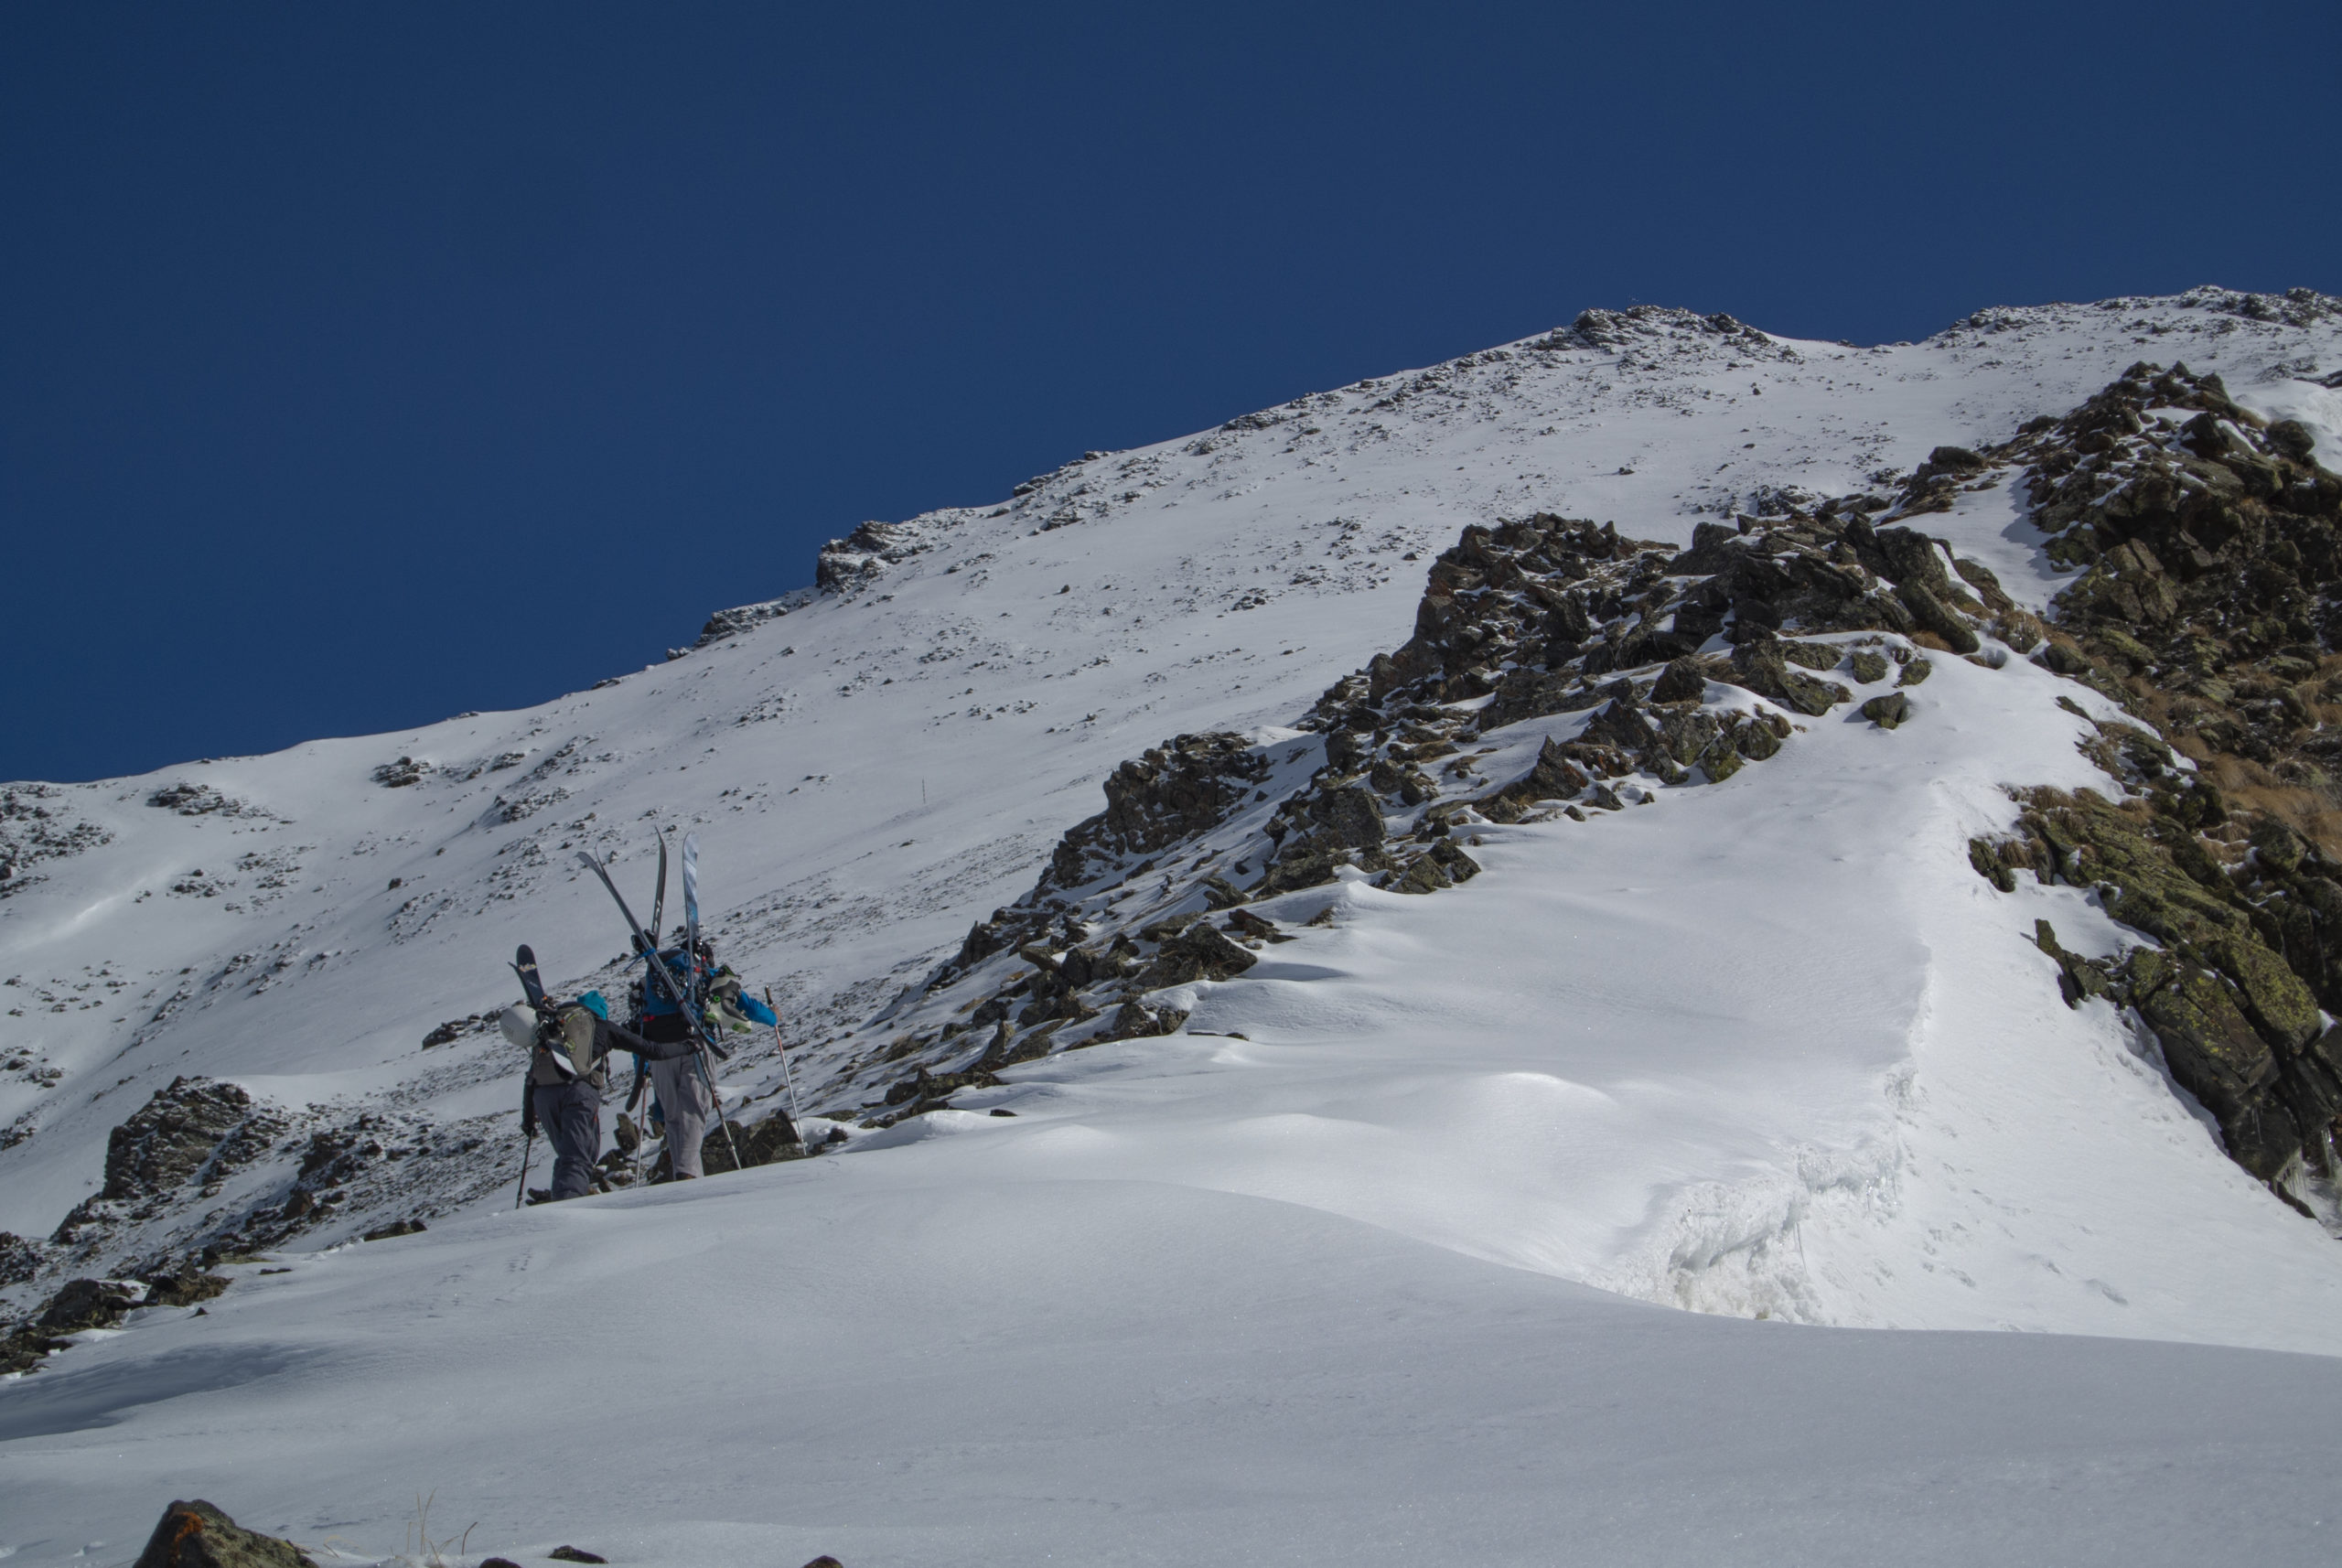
0, 0, 2342, 779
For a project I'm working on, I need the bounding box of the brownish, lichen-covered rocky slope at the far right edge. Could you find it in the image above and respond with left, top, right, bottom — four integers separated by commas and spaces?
1958, 365, 2342, 1219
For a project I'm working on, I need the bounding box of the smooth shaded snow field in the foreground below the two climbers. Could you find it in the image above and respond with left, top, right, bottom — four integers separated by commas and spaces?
0, 1175, 2342, 1568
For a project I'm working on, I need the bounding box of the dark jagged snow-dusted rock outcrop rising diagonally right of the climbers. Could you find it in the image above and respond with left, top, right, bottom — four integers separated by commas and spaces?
810, 479, 2042, 1125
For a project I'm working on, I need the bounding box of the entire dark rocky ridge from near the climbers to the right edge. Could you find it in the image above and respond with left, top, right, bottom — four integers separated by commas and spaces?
805, 346, 2342, 1233
